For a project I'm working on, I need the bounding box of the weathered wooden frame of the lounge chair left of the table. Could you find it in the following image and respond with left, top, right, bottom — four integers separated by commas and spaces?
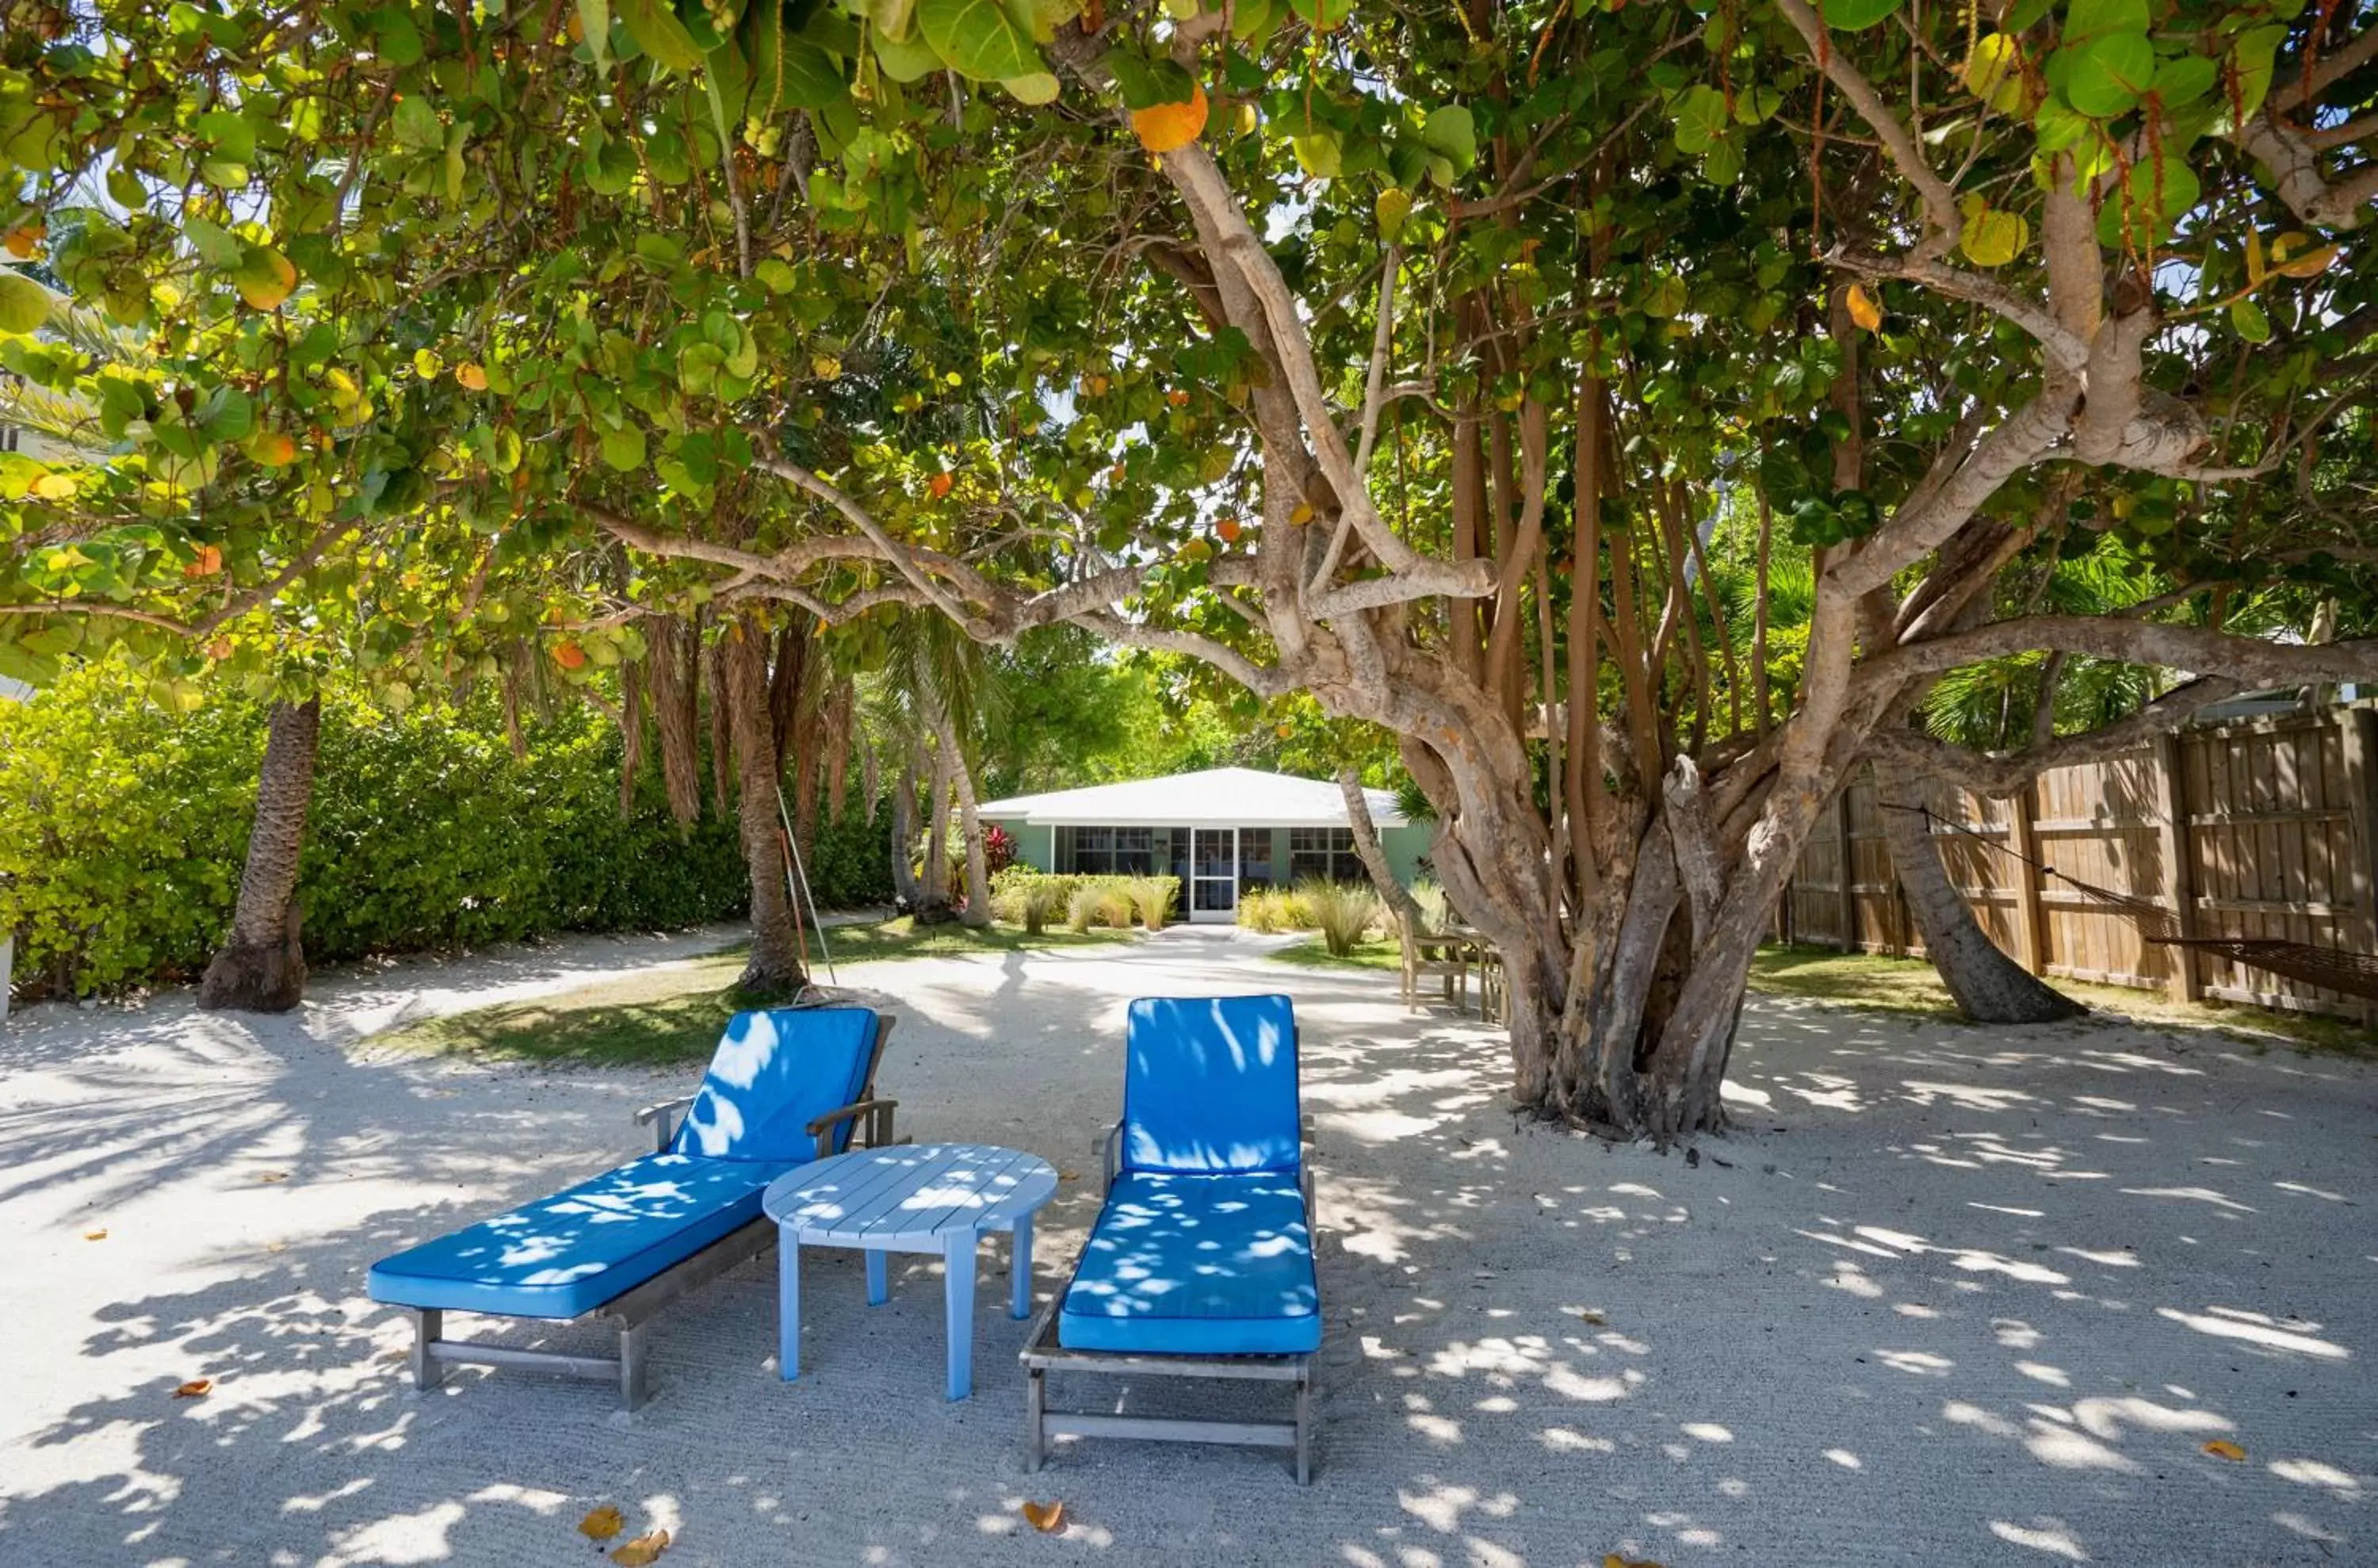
407, 1014, 899, 1411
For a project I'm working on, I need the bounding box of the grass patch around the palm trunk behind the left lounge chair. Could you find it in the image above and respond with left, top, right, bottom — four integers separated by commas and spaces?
373, 916, 1130, 1066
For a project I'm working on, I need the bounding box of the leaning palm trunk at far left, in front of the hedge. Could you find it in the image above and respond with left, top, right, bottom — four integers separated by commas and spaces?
197, 697, 321, 1014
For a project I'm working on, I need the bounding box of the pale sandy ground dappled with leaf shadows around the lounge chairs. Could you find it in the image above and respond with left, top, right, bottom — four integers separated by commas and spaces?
0, 933, 2378, 1568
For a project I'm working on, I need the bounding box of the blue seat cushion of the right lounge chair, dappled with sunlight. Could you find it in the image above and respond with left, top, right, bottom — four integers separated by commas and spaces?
1056, 1171, 1322, 1356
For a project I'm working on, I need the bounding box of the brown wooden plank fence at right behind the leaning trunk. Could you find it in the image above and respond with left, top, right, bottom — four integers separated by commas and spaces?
1776, 704, 2378, 1023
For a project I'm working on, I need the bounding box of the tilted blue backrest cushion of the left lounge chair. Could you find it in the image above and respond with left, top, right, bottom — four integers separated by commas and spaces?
671, 1007, 875, 1164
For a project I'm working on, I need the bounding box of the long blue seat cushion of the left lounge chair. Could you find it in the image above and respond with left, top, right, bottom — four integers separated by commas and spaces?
371, 1151, 785, 1318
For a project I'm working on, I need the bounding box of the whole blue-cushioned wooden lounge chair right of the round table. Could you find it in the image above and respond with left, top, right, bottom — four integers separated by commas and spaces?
1023, 997, 1322, 1485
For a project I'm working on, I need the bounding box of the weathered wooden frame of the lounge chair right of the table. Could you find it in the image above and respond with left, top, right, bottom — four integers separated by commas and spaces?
1018, 1116, 1320, 1487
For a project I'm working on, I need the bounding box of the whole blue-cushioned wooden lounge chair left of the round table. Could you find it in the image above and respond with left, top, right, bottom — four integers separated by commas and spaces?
369, 1007, 899, 1411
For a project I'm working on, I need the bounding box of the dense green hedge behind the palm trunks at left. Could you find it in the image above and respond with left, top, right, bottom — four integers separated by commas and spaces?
0, 664, 892, 995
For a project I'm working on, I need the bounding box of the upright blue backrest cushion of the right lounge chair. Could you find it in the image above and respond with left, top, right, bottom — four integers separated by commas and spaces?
1122, 997, 1303, 1185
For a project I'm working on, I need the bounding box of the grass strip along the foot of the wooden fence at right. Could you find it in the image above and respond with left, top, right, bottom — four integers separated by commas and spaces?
1750, 945, 2378, 1059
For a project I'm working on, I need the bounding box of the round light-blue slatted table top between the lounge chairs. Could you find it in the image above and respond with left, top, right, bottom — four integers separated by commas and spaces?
761, 1145, 1056, 1247
